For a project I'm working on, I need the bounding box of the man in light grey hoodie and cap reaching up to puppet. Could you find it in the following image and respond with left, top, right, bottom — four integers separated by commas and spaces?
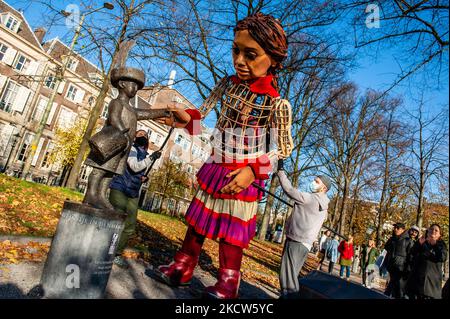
277, 165, 331, 298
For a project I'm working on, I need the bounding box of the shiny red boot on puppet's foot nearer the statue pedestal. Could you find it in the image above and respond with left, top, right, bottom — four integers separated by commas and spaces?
157, 251, 198, 286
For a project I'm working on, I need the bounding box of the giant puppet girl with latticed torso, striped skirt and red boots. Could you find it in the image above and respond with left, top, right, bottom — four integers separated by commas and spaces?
158, 13, 293, 298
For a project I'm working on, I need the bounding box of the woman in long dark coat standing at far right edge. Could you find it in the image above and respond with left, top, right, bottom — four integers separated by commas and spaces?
407, 224, 447, 299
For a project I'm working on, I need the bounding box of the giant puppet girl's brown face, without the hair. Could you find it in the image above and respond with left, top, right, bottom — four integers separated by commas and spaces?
233, 30, 275, 81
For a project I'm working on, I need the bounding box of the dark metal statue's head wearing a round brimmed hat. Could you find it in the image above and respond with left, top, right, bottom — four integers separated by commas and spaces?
111, 67, 145, 98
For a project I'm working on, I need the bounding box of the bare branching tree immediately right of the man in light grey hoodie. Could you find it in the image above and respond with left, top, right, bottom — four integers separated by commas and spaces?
318, 83, 382, 232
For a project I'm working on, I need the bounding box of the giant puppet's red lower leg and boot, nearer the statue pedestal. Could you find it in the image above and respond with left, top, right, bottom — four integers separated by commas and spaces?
157, 226, 205, 286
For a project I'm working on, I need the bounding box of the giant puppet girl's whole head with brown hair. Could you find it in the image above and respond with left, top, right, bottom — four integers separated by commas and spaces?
233, 13, 288, 80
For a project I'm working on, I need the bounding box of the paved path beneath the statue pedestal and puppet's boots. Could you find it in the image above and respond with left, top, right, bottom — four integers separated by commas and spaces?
0, 236, 278, 299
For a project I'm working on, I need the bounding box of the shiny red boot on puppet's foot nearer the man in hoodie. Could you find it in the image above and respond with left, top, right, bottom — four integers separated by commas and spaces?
206, 269, 241, 299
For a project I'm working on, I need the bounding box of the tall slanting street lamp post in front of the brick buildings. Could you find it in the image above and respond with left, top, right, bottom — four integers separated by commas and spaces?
23, 2, 114, 178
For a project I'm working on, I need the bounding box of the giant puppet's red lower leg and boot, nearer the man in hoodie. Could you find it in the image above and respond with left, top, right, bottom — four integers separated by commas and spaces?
206, 240, 243, 299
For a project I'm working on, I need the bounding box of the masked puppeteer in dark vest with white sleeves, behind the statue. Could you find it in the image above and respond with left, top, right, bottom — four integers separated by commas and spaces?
109, 130, 161, 268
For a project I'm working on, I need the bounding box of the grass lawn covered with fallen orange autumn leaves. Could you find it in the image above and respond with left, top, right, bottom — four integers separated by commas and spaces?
0, 174, 282, 290
